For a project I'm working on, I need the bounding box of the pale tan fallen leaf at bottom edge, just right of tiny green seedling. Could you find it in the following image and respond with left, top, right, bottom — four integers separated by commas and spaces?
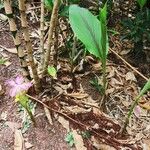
72, 130, 87, 150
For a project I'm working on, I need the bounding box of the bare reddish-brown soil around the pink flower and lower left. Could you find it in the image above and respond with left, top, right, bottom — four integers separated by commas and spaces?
0, 32, 69, 150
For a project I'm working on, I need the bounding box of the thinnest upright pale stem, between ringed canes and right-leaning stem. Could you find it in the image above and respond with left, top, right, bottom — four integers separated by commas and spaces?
40, 0, 45, 66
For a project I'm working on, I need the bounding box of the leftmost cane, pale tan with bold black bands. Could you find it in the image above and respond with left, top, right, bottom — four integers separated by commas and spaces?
4, 0, 31, 80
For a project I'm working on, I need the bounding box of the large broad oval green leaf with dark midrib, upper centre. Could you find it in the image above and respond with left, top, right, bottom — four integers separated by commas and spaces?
69, 5, 104, 59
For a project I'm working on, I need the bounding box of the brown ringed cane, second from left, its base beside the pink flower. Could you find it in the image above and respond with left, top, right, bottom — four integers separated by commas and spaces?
18, 0, 41, 92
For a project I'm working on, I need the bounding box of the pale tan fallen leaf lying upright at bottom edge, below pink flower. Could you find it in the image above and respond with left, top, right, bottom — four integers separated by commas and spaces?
14, 130, 25, 150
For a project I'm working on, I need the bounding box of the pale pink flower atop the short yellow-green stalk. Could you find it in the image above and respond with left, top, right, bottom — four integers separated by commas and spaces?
6, 75, 32, 97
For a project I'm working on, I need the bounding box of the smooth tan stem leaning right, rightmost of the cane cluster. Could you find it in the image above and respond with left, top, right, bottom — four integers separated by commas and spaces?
42, 0, 60, 76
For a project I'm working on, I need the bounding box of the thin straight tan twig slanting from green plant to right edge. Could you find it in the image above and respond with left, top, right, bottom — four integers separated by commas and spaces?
109, 48, 148, 81
